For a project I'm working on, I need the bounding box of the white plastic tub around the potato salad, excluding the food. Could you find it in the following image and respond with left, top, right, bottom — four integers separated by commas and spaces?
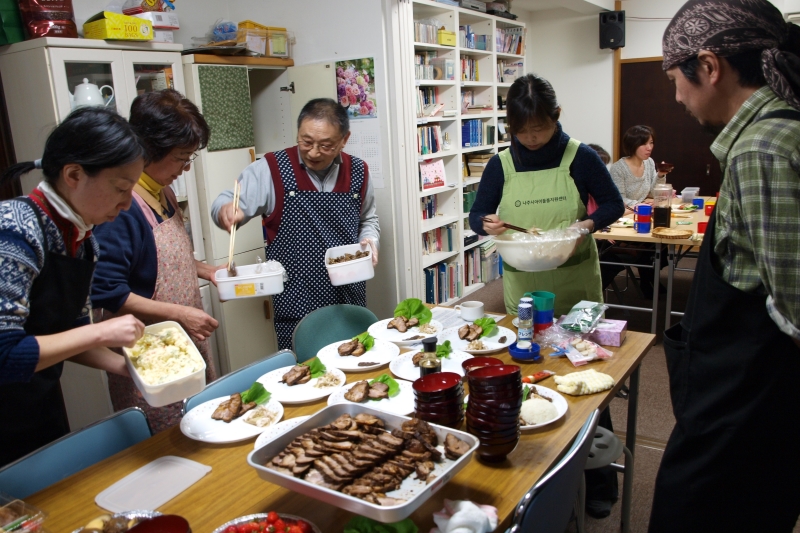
122, 321, 206, 407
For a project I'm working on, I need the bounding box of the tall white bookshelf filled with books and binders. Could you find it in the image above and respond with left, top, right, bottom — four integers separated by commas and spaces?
409, 0, 526, 305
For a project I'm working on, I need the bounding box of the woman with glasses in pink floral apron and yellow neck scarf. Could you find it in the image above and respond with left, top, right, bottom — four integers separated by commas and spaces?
92, 89, 219, 431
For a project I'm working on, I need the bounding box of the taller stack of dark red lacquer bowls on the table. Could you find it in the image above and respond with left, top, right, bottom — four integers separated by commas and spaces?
466, 365, 522, 462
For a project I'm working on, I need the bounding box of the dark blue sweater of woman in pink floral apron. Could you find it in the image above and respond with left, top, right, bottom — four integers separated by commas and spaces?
92, 201, 174, 313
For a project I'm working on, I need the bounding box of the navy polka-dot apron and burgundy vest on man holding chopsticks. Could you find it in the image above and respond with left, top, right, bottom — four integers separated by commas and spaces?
264, 147, 367, 349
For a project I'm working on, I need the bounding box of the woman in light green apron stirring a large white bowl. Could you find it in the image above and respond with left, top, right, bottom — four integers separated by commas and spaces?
469, 74, 625, 316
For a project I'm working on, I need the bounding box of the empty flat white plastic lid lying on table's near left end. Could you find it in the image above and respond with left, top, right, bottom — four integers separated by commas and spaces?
94, 455, 211, 513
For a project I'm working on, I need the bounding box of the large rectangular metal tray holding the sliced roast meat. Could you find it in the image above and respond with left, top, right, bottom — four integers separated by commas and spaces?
247, 403, 478, 523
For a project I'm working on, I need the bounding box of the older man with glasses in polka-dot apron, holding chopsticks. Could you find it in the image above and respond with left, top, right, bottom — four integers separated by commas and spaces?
211, 98, 380, 349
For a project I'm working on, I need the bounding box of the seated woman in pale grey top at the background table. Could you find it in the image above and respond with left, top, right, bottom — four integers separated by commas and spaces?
609, 126, 666, 213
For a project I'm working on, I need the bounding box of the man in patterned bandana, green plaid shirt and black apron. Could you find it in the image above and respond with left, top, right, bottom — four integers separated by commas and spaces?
649, 0, 800, 533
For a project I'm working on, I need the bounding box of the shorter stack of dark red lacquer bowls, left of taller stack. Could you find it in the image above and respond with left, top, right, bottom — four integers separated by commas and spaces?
413, 372, 464, 429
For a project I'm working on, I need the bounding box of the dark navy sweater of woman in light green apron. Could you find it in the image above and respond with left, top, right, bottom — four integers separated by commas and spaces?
469, 122, 625, 235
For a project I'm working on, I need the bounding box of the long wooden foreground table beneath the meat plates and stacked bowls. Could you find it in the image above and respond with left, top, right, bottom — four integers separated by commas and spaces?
26, 317, 655, 533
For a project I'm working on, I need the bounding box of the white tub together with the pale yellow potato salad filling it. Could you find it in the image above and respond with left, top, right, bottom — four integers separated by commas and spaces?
123, 321, 206, 407
